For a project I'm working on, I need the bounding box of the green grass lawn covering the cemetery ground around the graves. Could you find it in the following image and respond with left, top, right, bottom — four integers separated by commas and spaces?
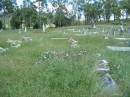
0, 25, 130, 97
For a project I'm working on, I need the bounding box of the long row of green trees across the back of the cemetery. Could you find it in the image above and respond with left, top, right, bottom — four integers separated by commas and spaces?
0, 0, 130, 29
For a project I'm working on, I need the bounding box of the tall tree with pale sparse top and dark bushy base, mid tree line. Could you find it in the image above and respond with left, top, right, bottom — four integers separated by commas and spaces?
50, 0, 71, 27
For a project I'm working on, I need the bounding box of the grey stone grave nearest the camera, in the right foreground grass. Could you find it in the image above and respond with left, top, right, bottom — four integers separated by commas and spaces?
96, 59, 119, 93
